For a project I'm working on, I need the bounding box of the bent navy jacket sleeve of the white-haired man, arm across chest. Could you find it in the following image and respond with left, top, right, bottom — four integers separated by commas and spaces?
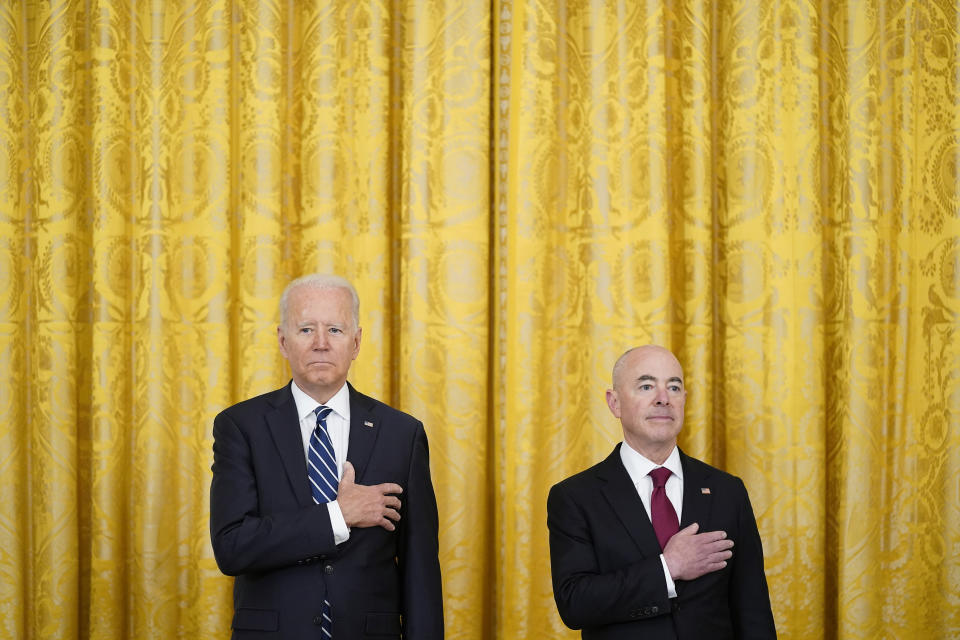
210, 413, 336, 576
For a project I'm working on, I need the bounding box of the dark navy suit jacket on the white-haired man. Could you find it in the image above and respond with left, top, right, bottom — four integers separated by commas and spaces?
210, 384, 443, 640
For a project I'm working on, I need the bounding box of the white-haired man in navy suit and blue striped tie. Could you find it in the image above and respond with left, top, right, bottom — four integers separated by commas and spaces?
210, 275, 443, 640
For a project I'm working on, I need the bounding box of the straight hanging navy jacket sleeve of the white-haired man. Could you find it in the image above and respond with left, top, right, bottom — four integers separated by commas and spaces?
397, 422, 443, 640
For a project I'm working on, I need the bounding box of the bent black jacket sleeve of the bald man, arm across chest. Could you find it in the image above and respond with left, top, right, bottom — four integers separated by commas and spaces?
547, 485, 670, 629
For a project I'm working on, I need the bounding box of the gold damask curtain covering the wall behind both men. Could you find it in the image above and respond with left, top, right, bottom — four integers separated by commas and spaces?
0, 0, 960, 640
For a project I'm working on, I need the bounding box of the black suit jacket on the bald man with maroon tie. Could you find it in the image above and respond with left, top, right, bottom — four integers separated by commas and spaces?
547, 445, 776, 640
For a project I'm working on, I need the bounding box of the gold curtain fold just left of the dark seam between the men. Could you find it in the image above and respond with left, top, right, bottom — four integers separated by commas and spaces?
392, 0, 497, 638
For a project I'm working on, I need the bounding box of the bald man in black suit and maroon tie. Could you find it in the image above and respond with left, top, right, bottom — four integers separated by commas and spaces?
547, 345, 776, 640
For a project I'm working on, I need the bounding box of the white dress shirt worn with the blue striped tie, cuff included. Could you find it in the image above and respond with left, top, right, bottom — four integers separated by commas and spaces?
290, 382, 350, 544
